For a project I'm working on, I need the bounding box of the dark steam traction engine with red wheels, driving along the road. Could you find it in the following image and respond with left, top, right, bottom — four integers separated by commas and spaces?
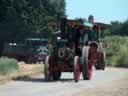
44, 18, 109, 82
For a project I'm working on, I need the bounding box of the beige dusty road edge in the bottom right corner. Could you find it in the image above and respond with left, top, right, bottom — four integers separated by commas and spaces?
73, 78, 128, 96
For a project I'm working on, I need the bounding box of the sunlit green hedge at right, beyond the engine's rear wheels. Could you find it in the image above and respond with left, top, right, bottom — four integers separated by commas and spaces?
102, 36, 128, 67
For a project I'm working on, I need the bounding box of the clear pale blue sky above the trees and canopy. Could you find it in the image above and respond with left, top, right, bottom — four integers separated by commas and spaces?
66, 0, 128, 23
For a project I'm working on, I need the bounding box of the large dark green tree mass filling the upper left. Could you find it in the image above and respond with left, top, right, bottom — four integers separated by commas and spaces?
0, 0, 65, 54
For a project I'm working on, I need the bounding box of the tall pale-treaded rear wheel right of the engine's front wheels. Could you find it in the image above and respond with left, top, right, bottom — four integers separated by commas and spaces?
82, 46, 92, 80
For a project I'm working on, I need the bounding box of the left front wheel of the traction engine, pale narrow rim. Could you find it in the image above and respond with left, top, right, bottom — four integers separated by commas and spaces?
44, 56, 51, 81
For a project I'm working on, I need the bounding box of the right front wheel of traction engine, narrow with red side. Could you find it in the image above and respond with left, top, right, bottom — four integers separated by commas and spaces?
74, 56, 81, 82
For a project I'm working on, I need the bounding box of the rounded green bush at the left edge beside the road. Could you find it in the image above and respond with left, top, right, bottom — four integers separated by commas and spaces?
0, 57, 19, 75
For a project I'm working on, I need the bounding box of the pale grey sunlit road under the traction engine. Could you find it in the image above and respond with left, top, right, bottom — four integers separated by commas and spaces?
0, 68, 128, 96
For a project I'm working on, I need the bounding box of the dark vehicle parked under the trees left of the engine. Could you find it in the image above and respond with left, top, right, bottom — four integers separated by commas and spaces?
2, 38, 48, 63
